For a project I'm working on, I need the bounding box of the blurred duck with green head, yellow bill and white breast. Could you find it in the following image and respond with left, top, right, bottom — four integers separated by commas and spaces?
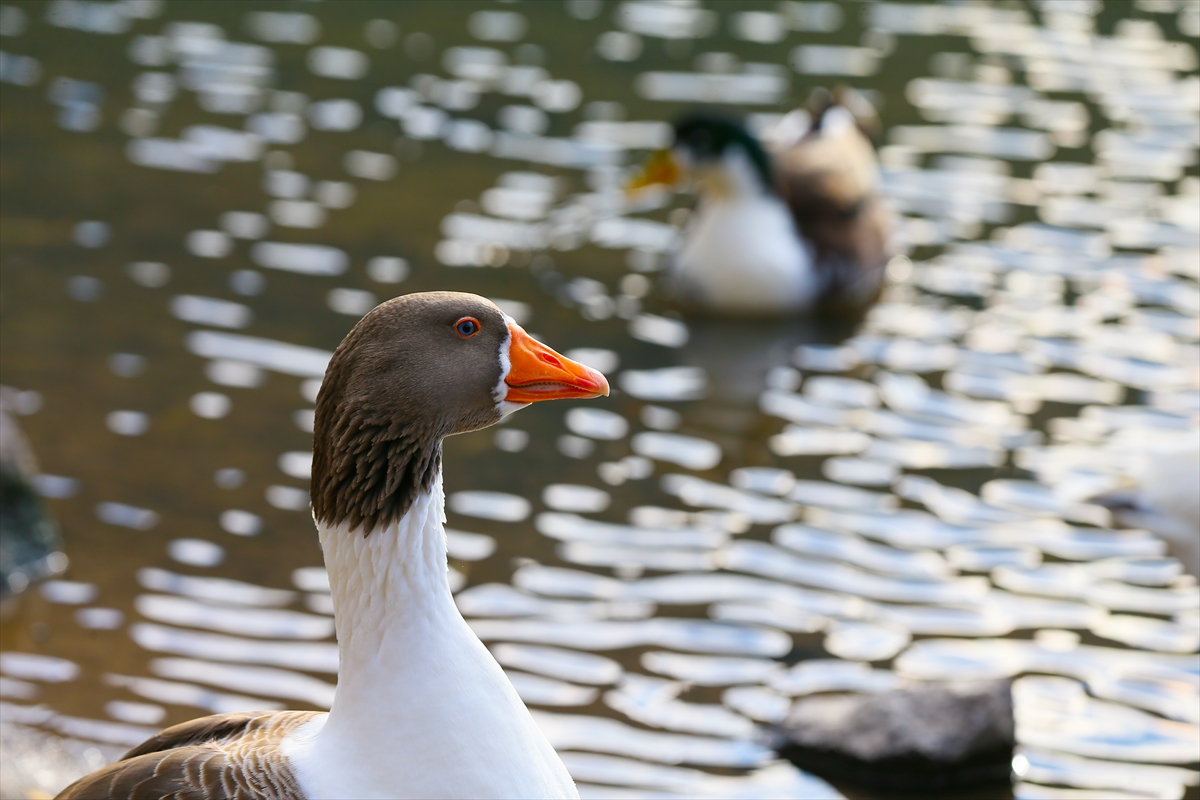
628, 89, 890, 317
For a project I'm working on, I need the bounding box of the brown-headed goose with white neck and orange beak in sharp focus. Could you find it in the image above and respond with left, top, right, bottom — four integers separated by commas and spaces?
59, 291, 608, 800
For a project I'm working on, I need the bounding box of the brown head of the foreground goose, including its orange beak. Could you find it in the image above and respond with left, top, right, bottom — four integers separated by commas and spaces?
312, 291, 608, 533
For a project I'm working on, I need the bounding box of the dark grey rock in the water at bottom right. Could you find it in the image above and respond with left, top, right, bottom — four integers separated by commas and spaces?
778, 680, 1014, 792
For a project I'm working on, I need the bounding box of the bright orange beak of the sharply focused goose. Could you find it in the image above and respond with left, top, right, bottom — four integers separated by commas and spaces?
504, 323, 608, 403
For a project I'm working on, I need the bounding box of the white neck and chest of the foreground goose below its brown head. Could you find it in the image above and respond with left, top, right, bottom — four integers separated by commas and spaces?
288, 474, 578, 799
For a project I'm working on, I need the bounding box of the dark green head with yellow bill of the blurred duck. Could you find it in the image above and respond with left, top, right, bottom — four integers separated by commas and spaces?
629, 112, 774, 194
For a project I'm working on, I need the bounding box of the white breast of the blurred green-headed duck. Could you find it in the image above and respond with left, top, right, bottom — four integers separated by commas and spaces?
670, 151, 820, 314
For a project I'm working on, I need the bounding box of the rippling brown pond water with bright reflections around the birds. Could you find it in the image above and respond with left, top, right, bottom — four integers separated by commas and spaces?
0, 0, 1200, 798
